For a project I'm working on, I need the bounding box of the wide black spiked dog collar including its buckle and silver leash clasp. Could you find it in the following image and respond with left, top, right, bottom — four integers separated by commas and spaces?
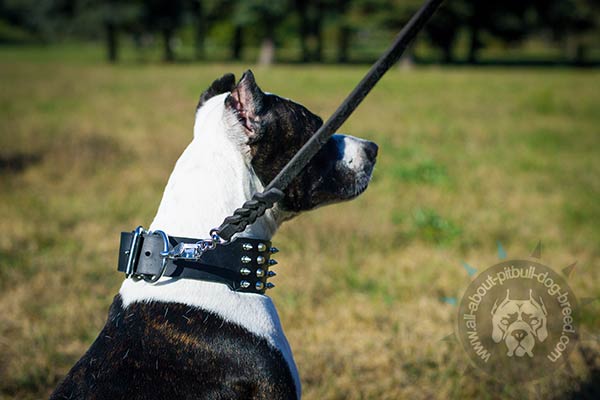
118, 226, 275, 294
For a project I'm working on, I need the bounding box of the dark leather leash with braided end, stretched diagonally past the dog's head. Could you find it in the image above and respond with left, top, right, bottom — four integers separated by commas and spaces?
210, 0, 443, 243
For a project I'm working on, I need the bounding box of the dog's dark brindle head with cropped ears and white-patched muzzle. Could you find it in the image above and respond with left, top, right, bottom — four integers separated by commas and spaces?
196, 71, 377, 218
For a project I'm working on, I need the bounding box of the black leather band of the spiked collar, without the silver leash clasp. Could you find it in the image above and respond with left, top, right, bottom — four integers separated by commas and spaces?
117, 228, 277, 294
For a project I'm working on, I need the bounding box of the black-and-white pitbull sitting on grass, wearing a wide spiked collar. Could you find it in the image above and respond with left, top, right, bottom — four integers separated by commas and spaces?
51, 71, 377, 399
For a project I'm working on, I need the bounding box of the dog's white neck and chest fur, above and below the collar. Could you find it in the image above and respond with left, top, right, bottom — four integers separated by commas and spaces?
120, 94, 300, 397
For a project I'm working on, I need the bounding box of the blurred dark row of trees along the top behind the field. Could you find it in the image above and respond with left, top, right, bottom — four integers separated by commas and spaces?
0, 0, 600, 64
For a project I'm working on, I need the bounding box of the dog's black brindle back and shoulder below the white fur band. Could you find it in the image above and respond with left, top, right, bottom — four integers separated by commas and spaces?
51, 296, 296, 399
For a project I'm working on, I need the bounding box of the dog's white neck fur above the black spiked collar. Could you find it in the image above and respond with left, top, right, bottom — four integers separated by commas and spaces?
150, 96, 278, 240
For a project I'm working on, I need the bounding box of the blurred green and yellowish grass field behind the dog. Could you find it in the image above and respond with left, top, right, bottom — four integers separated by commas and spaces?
0, 50, 600, 399
